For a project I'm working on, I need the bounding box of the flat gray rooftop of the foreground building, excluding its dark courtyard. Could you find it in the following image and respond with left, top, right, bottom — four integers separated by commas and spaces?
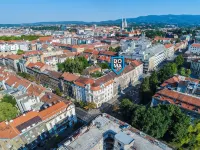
58, 114, 171, 150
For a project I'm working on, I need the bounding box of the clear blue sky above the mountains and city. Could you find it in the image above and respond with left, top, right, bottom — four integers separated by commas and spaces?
0, 0, 200, 24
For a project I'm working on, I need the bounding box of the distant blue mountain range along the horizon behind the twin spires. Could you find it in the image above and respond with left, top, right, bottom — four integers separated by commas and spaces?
0, 15, 200, 26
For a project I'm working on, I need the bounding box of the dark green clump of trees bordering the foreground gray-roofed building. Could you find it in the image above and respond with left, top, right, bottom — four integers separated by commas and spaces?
120, 99, 190, 142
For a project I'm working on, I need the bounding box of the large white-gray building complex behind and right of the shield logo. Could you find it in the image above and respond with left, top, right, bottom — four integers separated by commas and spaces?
119, 37, 167, 73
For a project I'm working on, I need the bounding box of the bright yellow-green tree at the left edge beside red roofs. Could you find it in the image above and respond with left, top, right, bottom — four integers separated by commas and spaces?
0, 102, 18, 122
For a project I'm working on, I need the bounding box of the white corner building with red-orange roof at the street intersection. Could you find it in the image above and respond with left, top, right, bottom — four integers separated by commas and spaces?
73, 75, 114, 107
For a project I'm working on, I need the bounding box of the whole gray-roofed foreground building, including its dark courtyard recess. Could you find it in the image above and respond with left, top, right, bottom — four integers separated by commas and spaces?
58, 114, 172, 150
